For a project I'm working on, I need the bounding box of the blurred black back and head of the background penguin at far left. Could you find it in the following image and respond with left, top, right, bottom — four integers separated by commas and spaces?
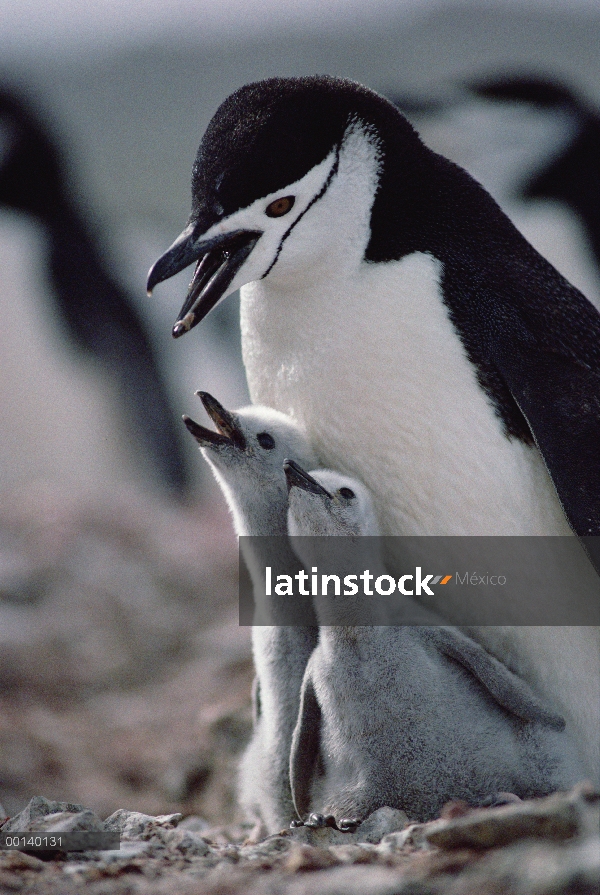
0, 89, 190, 496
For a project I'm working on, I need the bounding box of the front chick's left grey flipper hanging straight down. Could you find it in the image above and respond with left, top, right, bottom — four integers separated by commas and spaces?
290, 666, 321, 820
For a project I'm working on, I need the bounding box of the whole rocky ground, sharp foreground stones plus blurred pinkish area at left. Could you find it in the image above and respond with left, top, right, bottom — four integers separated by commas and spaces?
0, 483, 600, 895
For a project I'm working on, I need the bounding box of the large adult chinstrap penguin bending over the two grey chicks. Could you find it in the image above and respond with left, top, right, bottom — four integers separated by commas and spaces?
148, 77, 600, 780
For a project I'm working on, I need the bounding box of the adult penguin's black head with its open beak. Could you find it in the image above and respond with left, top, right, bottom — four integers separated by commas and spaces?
148, 76, 424, 336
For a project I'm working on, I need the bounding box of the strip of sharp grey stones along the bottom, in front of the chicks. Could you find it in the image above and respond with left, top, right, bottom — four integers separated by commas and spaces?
0, 786, 600, 895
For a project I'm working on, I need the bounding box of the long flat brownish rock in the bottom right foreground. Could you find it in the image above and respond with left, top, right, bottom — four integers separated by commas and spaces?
425, 787, 594, 848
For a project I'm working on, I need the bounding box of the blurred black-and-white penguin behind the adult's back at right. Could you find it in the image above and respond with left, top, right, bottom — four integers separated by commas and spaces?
389, 74, 600, 309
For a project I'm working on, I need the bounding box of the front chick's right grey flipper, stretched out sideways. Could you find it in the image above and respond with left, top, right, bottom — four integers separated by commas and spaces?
421, 626, 565, 730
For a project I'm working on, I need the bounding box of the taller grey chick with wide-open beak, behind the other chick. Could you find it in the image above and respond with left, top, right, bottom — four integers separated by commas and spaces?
184, 392, 318, 838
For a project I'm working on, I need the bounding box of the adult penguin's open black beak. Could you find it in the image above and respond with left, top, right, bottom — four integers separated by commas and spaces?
147, 222, 262, 339
